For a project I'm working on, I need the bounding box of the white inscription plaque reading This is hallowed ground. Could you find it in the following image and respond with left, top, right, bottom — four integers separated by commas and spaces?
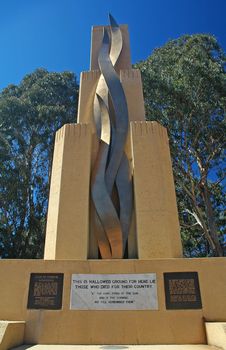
70, 273, 158, 310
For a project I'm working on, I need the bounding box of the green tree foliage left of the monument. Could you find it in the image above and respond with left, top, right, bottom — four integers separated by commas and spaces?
0, 69, 78, 258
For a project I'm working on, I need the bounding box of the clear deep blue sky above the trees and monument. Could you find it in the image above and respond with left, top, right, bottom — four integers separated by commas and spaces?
0, 0, 226, 89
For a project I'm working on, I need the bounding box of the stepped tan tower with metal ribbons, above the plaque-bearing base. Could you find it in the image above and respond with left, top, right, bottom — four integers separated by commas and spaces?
45, 17, 182, 259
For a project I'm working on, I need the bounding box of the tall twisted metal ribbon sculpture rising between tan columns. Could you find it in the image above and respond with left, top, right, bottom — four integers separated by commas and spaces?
91, 15, 132, 259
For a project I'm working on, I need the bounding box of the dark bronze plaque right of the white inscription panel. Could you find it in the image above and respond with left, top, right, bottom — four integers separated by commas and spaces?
164, 272, 202, 310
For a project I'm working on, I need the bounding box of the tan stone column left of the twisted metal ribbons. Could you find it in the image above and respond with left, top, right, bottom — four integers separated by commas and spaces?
44, 124, 92, 260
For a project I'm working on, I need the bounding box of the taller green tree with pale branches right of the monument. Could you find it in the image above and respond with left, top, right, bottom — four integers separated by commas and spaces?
135, 34, 226, 256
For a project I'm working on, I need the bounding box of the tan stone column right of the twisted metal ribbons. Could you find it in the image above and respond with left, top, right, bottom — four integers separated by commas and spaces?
130, 122, 182, 259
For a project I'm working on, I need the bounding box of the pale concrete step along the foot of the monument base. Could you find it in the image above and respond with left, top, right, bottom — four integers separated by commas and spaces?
11, 344, 222, 350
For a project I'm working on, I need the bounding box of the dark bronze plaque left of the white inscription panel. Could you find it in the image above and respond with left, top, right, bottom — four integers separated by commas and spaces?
27, 273, 64, 310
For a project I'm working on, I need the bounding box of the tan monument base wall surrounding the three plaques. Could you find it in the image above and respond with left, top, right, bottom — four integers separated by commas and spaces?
0, 258, 226, 345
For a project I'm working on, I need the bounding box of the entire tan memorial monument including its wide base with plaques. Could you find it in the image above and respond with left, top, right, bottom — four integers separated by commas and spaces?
0, 16, 226, 349
